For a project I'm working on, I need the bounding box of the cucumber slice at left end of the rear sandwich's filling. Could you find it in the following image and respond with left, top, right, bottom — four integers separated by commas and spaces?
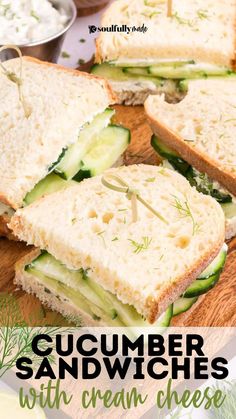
91, 63, 163, 86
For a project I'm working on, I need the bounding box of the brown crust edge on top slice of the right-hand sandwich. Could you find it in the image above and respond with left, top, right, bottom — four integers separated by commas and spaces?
144, 110, 236, 195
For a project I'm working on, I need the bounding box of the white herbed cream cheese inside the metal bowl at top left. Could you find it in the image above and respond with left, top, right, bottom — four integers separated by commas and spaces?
0, 0, 68, 45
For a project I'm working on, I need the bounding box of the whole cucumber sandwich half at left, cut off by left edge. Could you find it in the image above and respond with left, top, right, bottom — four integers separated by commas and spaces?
0, 57, 130, 237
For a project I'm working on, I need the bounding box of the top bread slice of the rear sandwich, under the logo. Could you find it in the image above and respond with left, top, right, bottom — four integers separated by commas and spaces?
96, 0, 236, 66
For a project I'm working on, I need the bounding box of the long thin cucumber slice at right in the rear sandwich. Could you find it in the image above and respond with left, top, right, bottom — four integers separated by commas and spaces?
148, 64, 230, 79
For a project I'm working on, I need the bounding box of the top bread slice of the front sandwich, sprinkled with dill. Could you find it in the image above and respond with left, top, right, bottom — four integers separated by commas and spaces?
9, 165, 225, 323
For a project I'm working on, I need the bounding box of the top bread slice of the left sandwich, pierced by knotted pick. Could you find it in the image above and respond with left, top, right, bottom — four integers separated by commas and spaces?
0, 58, 114, 209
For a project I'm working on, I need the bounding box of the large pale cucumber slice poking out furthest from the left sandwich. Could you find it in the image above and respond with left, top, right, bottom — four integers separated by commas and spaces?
74, 125, 130, 181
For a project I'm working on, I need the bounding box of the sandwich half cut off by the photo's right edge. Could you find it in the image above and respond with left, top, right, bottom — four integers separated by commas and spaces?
145, 79, 236, 239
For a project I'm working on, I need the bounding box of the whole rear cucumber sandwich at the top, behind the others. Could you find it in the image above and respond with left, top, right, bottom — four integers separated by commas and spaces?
92, 0, 236, 105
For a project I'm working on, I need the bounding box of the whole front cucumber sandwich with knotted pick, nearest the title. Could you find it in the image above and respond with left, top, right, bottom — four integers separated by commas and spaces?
9, 165, 227, 327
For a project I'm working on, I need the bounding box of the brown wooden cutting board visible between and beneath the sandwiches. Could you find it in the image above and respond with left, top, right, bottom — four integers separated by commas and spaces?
0, 106, 236, 327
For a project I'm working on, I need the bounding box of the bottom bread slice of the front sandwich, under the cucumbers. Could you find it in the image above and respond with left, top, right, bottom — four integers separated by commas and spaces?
14, 250, 98, 327
